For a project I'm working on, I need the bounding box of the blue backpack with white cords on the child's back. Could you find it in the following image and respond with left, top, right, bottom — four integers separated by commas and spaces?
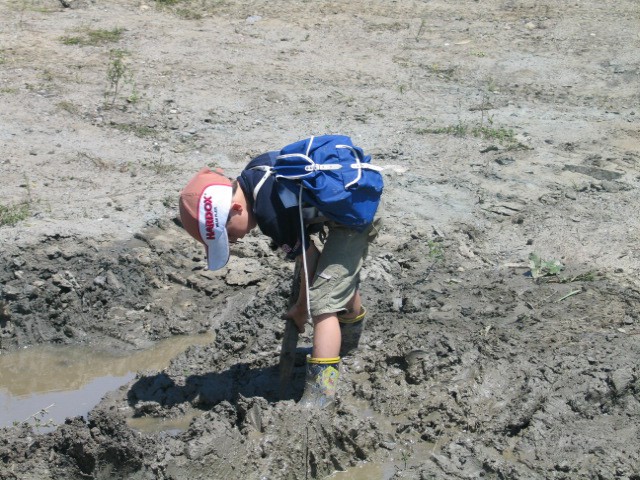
254, 135, 383, 231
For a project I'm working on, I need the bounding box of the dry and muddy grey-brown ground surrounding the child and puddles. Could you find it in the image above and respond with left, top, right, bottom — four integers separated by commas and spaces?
0, 0, 640, 479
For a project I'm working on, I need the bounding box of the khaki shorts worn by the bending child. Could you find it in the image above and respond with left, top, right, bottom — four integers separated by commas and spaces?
309, 218, 382, 316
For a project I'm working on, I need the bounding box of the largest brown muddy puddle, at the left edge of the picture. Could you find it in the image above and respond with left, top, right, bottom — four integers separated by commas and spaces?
0, 333, 214, 427
